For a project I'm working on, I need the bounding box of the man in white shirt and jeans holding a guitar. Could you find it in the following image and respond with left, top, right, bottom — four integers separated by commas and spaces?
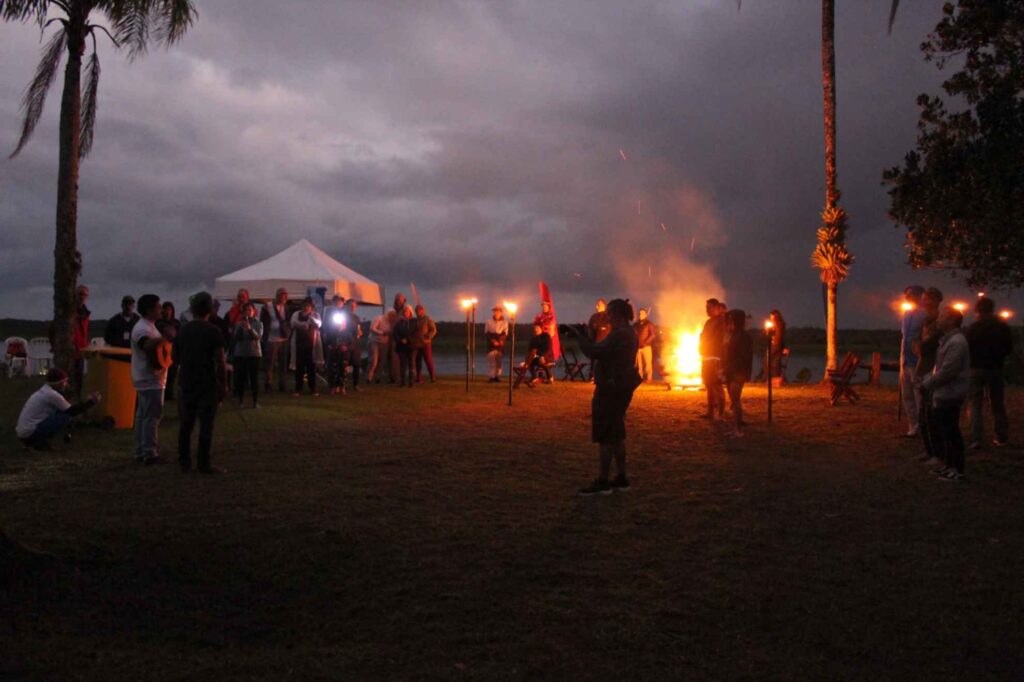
131, 294, 170, 465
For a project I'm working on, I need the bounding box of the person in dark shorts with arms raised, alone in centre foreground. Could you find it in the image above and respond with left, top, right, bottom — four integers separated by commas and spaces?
565, 298, 641, 495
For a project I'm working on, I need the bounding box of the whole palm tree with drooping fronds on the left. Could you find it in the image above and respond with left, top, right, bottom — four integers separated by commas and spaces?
0, 0, 196, 371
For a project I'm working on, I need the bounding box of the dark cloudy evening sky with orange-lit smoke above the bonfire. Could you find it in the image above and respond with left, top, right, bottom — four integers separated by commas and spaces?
0, 0, 1019, 327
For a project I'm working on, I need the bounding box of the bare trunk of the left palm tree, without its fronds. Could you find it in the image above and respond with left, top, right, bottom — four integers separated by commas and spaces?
53, 25, 85, 376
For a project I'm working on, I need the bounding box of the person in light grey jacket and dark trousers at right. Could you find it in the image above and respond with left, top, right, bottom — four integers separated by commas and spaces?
921, 308, 971, 481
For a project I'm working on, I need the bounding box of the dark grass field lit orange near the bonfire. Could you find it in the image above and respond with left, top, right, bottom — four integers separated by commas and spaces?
0, 378, 1024, 680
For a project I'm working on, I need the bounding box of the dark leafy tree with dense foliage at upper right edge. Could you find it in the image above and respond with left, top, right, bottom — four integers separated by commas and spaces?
883, 0, 1024, 287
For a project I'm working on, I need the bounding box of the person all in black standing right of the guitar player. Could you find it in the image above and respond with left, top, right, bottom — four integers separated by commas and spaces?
174, 291, 227, 474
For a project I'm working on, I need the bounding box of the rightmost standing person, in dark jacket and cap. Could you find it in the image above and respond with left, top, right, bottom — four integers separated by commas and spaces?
966, 296, 1014, 450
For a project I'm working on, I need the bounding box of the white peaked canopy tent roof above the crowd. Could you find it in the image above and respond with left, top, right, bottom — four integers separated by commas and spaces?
213, 239, 384, 305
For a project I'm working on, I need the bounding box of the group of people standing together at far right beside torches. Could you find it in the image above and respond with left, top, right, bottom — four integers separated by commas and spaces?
900, 286, 1013, 481
